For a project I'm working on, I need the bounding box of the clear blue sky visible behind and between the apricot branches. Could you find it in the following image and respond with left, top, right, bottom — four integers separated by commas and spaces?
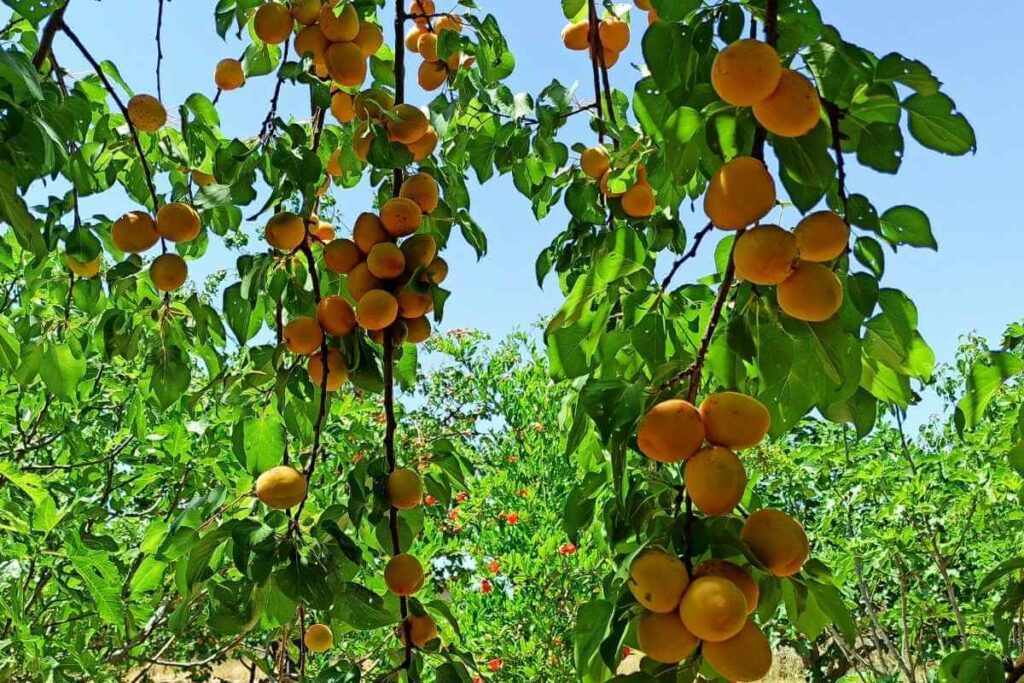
16, 0, 1024, 428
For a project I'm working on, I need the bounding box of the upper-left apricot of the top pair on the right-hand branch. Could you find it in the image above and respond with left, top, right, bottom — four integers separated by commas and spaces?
711, 39, 782, 106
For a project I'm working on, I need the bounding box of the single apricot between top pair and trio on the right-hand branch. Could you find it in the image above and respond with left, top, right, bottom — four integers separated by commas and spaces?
705, 157, 775, 230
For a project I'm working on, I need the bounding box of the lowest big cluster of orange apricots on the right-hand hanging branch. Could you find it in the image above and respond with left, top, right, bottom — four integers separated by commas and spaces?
628, 391, 810, 681
